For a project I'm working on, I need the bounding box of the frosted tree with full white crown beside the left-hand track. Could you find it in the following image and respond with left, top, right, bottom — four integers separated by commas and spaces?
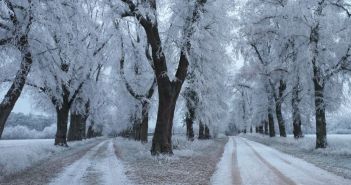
26, 1, 116, 145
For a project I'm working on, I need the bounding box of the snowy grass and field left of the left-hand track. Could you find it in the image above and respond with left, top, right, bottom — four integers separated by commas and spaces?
0, 139, 99, 179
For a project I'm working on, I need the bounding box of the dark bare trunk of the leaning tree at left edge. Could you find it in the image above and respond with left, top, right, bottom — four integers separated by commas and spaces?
0, 49, 33, 139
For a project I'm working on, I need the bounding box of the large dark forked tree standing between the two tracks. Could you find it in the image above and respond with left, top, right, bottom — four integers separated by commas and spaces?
114, 0, 212, 155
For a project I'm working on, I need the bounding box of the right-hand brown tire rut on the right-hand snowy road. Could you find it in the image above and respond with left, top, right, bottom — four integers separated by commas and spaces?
239, 138, 296, 185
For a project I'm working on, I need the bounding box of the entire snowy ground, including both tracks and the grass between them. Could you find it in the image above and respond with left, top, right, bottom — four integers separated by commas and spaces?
0, 135, 351, 185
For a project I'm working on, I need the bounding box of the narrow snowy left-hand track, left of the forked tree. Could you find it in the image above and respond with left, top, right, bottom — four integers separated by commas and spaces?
50, 140, 131, 185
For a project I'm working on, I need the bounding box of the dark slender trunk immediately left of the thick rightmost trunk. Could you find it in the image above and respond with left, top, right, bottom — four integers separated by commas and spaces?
292, 79, 303, 138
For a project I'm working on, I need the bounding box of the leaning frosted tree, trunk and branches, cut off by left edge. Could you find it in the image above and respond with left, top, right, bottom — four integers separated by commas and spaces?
0, 0, 34, 138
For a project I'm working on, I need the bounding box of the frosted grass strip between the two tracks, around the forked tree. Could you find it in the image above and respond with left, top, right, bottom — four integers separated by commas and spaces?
115, 135, 227, 185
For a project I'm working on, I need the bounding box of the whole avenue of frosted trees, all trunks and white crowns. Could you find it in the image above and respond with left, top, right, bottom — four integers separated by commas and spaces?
0, 0, 351, 155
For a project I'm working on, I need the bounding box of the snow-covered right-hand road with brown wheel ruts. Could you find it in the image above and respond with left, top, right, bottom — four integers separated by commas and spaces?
211, 137, 351, 185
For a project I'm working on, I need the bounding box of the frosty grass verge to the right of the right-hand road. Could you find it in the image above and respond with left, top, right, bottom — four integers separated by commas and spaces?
241, 134, 351, 179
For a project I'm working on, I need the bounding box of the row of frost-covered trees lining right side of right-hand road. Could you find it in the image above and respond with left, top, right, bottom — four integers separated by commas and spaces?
235, 0, 351, 148
